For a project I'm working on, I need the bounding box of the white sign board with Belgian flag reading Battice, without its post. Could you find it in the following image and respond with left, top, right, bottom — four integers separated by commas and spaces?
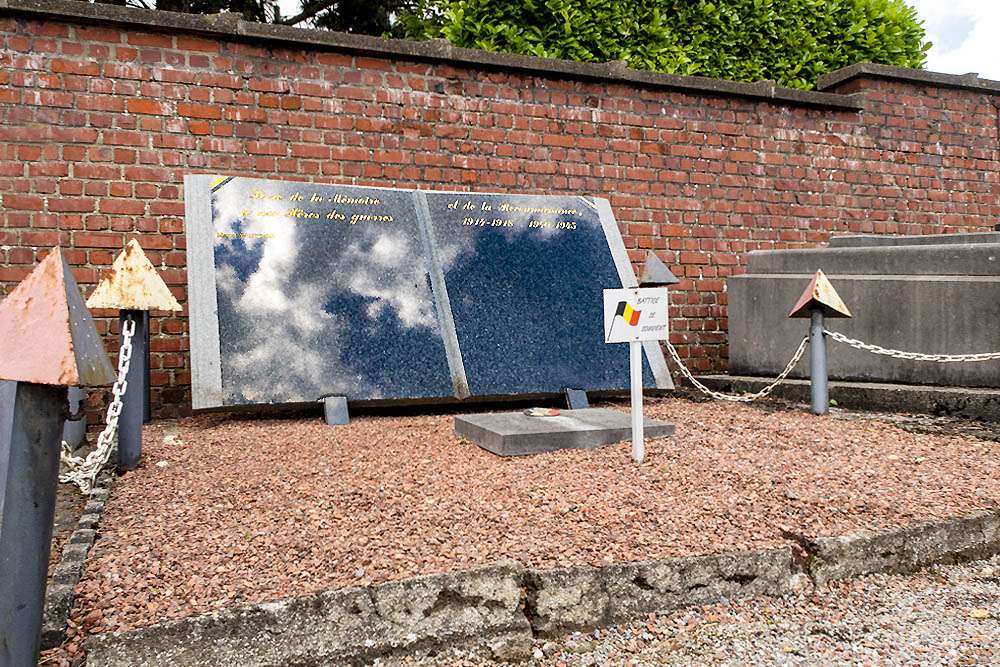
604, 287, 668, 343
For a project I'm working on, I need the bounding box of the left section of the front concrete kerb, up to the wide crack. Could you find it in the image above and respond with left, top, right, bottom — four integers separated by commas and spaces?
84, 561, 532, 667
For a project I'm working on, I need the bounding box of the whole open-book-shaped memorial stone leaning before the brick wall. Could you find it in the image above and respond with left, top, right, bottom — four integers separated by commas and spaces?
185, 176, 672, 409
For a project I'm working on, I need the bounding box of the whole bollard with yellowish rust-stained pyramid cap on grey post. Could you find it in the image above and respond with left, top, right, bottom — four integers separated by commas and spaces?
87, 239, 181, 470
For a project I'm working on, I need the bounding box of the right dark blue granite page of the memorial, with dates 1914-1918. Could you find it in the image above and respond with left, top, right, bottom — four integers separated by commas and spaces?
423, 192, 655, 395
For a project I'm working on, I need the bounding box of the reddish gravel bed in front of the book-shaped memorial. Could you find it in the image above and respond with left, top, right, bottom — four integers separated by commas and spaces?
37, 398, 1000, 664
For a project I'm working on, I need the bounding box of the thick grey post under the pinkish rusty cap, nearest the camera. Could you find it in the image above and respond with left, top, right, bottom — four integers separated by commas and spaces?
0, 382, 67, 667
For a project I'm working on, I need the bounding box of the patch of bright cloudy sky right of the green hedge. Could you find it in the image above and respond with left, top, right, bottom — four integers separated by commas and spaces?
907, 0, 1000, 81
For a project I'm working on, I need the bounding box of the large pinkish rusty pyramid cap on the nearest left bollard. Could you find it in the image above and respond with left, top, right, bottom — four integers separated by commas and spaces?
0, 248, 115, 387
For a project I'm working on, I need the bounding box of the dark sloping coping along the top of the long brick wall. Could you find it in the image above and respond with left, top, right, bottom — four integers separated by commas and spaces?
0, 0, 872, 111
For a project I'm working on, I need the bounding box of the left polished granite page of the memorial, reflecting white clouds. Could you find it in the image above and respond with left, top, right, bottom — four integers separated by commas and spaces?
205, 178, 453, 407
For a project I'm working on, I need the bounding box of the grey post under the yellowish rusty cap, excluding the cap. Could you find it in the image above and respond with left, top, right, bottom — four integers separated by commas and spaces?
118, 310, 149, 470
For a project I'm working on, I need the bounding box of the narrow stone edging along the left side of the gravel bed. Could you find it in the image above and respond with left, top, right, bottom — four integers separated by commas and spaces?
41, 466, 114, 651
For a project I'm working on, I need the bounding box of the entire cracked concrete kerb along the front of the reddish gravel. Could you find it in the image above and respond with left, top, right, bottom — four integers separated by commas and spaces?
84, 509, 1000, 667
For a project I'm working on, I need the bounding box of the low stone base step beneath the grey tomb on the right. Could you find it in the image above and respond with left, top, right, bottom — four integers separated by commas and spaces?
683, 375, 1000, 422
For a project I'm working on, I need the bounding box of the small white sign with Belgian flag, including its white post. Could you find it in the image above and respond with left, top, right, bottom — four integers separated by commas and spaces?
604, 287, 668, 463
